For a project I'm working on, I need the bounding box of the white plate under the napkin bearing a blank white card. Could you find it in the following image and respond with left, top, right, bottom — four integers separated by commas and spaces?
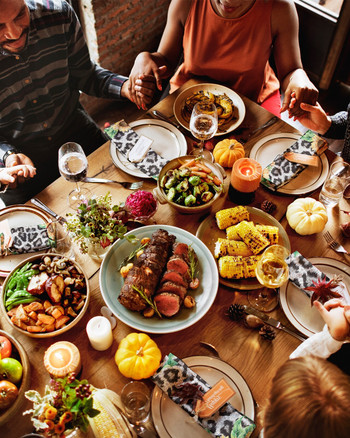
109, 119, 187, 178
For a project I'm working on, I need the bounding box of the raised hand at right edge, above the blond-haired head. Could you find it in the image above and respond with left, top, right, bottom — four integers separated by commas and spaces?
314, 298, 350, 341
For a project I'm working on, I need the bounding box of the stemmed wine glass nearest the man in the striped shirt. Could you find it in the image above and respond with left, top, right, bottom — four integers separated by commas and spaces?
58, 142, 91, 209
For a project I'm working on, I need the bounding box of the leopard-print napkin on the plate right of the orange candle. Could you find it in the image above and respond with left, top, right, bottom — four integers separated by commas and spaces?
261, 130, 328, 190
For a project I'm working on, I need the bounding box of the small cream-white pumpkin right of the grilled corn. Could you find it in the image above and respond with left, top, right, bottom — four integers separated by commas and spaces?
286, 198, 328, 236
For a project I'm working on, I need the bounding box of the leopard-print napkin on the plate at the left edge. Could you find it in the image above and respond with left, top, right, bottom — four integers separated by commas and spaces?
0, 220, 55, 256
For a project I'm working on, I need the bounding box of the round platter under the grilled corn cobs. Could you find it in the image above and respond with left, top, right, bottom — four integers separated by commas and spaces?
196, 206, 290, 290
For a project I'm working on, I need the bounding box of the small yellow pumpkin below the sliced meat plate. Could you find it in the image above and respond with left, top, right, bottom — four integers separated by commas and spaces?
115, 333, 162, 380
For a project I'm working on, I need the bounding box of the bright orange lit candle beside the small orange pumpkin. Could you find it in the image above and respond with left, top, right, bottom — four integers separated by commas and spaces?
231, 158, 262, 193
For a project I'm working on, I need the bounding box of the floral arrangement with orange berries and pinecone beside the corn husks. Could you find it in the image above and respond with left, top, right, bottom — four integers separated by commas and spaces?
23, 373, 100, 438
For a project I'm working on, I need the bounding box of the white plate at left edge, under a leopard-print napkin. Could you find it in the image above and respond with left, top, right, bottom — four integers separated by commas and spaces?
0, 204, 52, 277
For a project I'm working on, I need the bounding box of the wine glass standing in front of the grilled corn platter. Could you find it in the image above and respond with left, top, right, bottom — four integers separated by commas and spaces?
248, 245, 290, 312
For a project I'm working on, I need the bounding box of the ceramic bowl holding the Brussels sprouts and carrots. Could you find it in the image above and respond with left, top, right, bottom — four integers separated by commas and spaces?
153, 155, 226, 214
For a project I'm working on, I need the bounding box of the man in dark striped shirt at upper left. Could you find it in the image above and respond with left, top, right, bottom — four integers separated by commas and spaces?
0, 0, 155, 204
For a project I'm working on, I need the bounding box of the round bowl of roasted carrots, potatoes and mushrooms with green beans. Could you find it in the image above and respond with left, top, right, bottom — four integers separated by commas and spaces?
0, 253, 90, 338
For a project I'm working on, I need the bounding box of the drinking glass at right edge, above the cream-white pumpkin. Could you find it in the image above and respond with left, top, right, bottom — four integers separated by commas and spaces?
319, 161, 350, 207
